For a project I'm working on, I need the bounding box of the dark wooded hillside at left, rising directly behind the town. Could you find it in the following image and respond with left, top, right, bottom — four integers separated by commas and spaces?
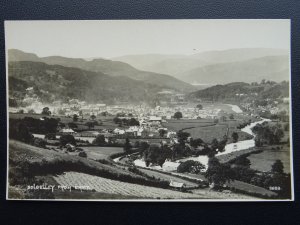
8, 61, 180, 104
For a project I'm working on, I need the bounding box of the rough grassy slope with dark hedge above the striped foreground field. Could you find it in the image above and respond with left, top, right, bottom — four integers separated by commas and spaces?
9, 140, 168, 193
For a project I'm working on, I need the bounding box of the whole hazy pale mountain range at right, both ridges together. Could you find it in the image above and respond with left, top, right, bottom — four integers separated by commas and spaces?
113, 48, 289, 85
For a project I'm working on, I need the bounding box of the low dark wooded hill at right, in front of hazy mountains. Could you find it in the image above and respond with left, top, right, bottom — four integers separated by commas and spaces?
188, 81, 289, 102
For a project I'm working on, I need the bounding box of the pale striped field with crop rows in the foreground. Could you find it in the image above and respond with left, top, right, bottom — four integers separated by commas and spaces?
54, 172, 206, 199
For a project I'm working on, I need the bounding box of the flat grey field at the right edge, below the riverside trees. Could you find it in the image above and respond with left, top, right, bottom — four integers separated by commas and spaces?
248, 145, 291, 173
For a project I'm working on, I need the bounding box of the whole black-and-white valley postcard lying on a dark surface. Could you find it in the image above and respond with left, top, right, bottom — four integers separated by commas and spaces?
4, 19, 294, 202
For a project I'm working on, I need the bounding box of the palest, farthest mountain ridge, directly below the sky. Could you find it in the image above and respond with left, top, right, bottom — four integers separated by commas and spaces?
114, 48, 288, 83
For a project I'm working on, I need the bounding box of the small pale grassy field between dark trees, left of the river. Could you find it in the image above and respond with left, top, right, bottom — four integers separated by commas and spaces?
82, 147, 124, 160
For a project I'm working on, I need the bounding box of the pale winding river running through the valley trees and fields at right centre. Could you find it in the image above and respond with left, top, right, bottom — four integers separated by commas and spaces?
134, 119, 270, 171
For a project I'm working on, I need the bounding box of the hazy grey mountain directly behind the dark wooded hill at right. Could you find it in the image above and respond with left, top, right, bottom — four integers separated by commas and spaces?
183, 56, 289, 84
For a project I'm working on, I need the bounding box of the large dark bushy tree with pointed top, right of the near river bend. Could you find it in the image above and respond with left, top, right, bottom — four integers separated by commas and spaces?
205, 157, 234, 188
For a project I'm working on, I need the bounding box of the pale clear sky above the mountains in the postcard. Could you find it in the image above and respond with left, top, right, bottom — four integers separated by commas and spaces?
5, 19, 290, 58
